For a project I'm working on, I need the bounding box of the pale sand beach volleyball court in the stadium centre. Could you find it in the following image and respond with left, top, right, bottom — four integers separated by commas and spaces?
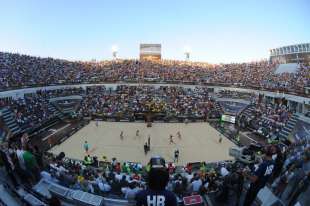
50, 121, 234, 165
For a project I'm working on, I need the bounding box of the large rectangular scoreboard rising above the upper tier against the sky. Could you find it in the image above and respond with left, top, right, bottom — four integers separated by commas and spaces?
140, 44, 161, 60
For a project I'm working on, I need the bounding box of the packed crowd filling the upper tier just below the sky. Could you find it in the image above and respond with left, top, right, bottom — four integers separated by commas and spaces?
0, 52, 310, 94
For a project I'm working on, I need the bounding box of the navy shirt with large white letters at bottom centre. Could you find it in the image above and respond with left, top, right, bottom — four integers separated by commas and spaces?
136, 189, 177, 206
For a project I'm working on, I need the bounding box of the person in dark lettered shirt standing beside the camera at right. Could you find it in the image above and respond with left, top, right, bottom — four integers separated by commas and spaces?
244, 146, 275, 206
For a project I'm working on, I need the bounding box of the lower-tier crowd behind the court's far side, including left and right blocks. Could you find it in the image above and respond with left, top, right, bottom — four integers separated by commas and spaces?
0, 85, 294, 146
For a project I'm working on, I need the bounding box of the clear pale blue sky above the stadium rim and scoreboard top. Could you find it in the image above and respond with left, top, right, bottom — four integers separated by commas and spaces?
0, 0, 310, 63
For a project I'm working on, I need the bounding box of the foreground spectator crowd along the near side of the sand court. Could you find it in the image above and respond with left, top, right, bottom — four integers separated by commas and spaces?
0, 132, 310, 205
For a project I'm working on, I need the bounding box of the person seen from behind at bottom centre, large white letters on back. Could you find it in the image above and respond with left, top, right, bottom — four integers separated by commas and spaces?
136, 167, 177, 206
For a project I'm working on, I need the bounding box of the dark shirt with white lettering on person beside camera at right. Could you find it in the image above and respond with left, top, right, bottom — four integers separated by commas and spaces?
254, 160, 274, 187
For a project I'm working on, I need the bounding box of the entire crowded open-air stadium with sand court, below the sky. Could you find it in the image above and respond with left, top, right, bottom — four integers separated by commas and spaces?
0, 1, 310, 206
